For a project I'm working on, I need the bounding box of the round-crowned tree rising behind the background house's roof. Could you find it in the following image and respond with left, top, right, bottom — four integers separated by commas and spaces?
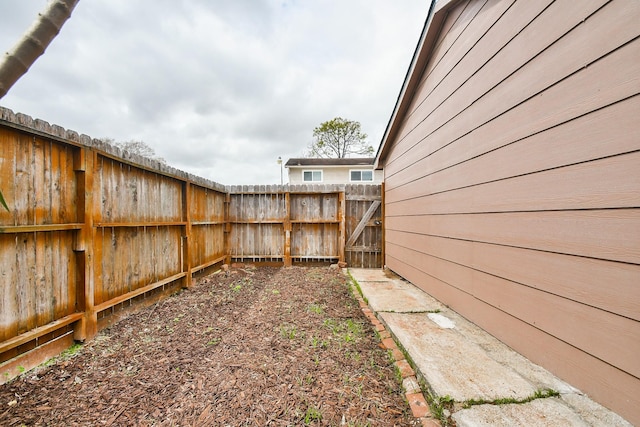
306, 117, 373, 159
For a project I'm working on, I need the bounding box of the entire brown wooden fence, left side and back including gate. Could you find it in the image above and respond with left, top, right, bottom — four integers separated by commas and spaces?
0, 108, 382, 383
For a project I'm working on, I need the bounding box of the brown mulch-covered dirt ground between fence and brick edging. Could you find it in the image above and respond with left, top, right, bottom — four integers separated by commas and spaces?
0, 267, 415, 426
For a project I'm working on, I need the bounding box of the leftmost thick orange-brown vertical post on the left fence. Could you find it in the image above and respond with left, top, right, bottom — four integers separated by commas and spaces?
73, 148, 98, 341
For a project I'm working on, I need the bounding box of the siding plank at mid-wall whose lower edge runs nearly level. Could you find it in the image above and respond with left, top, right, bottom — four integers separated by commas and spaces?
387, 151, 640, 216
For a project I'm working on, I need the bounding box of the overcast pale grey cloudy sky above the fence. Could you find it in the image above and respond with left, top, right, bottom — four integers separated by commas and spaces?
0, 0, 429, 185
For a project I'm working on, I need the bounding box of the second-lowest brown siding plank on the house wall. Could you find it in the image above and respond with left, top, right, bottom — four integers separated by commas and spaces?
387, 243, 640, 377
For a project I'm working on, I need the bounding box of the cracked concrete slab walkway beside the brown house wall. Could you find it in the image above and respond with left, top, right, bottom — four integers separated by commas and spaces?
349, 269, 631, 427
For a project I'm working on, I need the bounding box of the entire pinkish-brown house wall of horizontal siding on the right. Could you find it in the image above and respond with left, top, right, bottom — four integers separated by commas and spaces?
380, 0, 640, 424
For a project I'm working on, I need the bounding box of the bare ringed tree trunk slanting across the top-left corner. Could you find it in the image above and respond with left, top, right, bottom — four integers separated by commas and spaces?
0, 0, 79, 98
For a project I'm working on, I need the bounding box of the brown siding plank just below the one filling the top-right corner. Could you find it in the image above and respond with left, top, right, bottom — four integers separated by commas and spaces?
385, 39, 640, 186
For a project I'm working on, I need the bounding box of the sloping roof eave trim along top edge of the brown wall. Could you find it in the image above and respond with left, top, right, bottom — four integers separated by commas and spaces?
373, 0, 460, 169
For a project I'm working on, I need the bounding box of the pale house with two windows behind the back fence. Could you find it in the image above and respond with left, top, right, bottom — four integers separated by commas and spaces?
284, 157, 383, 184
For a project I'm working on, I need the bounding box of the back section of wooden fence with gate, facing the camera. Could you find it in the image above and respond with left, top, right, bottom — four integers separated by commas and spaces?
227, 185, 382, 268
